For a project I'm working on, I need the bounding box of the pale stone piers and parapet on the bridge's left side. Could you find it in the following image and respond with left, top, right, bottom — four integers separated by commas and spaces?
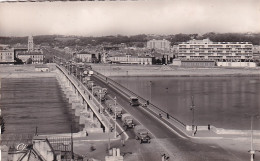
57, 67, 110, 135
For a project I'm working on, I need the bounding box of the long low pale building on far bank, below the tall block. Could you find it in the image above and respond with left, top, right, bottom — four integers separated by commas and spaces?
108, 55, 152, 65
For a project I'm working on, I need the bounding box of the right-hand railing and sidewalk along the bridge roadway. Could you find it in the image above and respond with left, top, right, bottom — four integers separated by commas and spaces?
94, 71, 186, 128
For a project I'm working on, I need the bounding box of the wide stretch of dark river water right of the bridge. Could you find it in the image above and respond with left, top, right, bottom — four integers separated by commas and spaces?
112, 77, 260, 130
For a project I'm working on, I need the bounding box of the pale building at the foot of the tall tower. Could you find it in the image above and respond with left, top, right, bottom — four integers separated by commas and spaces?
16, 51, 44, 64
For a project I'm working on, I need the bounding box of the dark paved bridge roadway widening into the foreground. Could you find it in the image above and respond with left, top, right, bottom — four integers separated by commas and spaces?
91, 76, 241, 161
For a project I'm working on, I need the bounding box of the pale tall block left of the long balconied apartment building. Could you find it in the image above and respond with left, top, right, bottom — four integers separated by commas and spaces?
147, 39, 170, 51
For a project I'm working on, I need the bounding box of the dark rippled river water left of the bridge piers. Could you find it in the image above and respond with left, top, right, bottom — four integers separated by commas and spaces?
0, 77, 78, 135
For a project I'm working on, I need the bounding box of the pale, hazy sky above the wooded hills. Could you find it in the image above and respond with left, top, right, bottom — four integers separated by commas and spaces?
0, 0, 260, 36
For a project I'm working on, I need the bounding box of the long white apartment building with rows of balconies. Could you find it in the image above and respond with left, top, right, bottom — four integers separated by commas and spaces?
178, 39, 253, 62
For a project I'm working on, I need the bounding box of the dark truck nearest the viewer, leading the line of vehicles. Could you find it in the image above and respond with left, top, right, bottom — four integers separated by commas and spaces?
134, 125, 151, 144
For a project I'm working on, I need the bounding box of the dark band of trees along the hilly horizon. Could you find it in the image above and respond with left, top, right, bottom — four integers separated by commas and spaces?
0, 32, 260, 47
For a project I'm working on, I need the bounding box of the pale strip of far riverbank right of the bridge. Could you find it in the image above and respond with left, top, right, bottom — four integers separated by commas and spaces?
92, 64, 260, 77
